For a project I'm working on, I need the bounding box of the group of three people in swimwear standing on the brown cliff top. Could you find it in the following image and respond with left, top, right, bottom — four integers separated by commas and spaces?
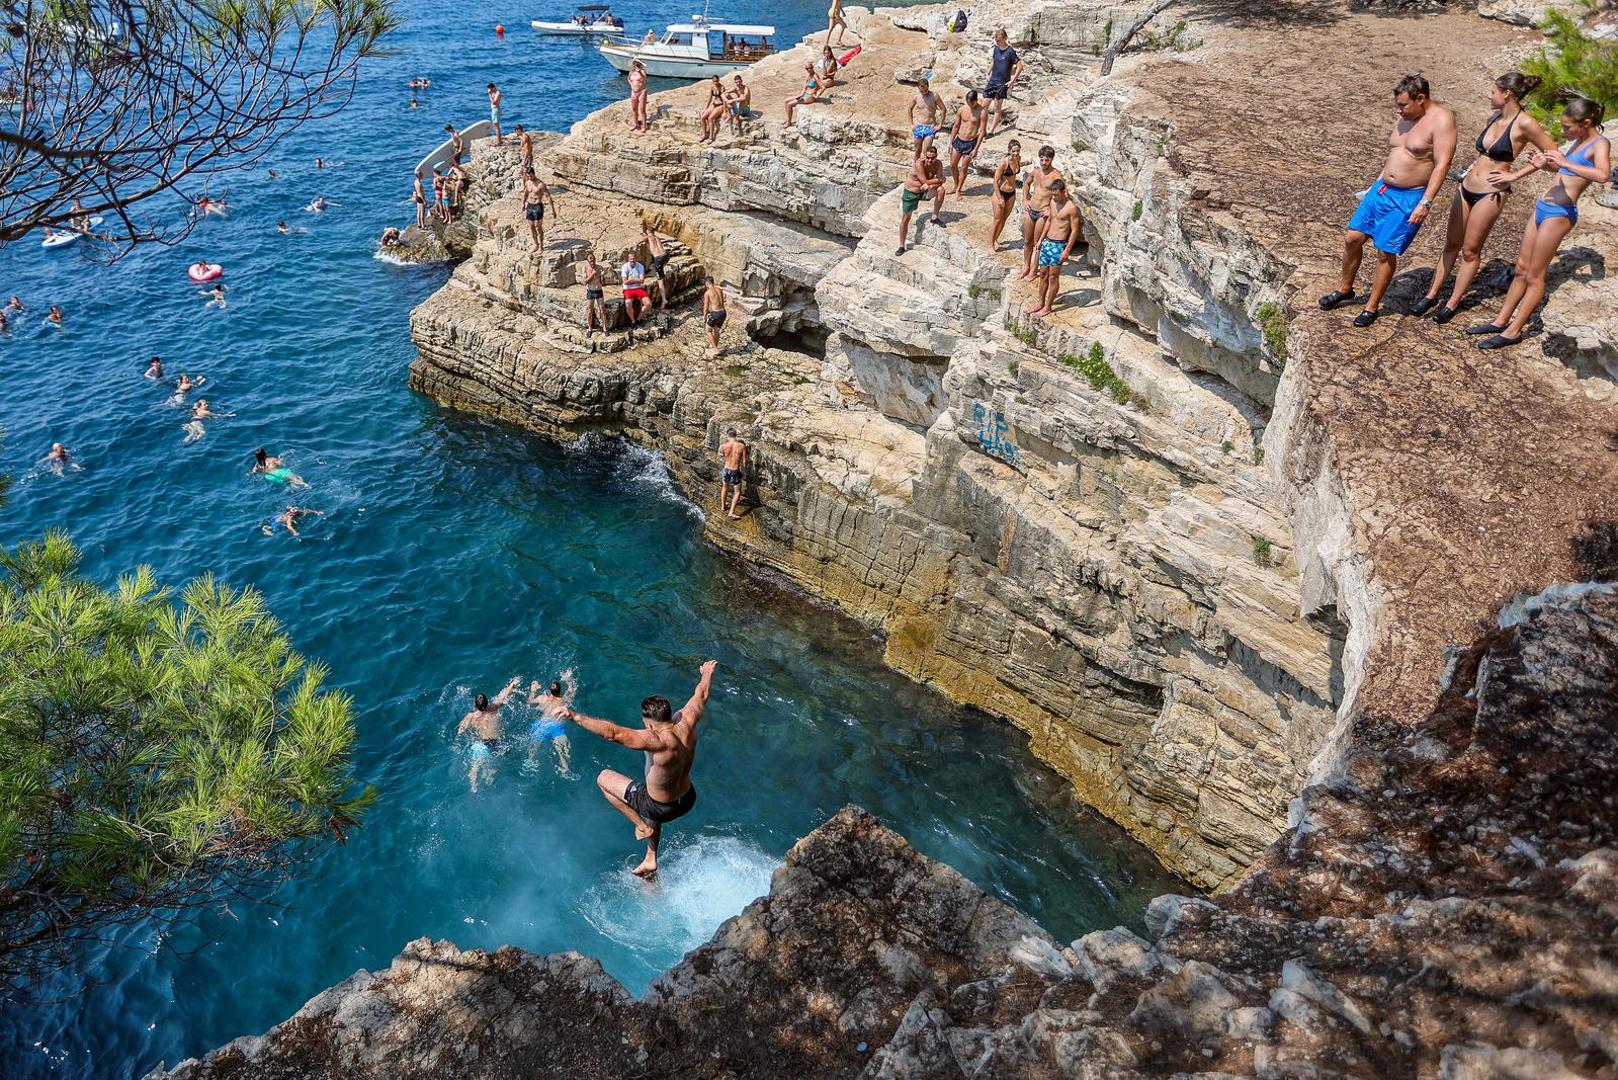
1320, 71, 1613, 350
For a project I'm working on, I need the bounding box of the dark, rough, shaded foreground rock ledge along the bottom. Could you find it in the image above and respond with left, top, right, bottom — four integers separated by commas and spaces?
152, 579, 1618, 1080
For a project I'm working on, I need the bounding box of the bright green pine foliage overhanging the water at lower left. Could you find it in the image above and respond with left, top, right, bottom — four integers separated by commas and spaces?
0, 533, 374, 997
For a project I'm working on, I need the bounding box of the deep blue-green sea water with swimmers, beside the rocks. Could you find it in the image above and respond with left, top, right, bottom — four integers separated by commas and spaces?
0, 0, 1175, 1077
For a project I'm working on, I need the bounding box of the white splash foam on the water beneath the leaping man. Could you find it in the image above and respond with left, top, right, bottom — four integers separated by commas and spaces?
578, 832, 781, 968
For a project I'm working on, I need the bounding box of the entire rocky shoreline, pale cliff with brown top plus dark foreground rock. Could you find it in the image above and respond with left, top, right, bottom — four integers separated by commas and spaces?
152, 0, 1618, 1077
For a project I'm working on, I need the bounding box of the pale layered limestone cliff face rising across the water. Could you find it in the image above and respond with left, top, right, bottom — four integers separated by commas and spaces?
413, 3, 1343, 886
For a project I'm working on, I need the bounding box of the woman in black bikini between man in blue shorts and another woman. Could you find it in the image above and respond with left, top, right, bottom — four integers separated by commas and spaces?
1411, 71, 1557, 322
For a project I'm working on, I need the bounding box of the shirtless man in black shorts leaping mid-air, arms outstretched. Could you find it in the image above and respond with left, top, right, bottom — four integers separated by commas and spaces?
566, 661, 718, 878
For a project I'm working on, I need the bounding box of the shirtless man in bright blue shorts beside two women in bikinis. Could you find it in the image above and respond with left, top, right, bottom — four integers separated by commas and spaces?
1320, 74, 1455, 327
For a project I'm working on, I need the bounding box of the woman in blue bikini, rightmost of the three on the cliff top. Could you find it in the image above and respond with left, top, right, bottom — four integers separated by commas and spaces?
1466, 97, 1613, 348
